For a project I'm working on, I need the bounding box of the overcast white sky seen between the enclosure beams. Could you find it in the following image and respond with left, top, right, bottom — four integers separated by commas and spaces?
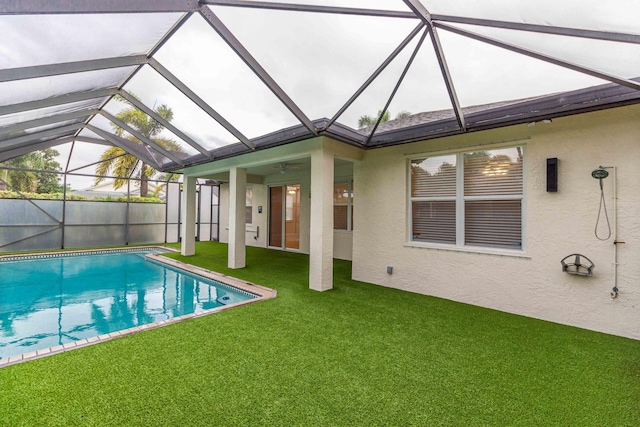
0, 0, 640, 189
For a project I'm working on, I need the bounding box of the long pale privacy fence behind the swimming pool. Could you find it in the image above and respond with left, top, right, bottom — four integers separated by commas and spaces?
0, 179, 219, 252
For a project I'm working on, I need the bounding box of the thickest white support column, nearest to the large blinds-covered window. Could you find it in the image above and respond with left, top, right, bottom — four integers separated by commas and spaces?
309, 148, 334, 291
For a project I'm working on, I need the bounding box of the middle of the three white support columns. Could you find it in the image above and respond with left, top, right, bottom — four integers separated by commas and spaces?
228, 168, 247, 268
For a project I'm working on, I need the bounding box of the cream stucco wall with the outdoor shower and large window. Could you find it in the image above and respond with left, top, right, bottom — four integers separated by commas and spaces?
353, 106, 640, 339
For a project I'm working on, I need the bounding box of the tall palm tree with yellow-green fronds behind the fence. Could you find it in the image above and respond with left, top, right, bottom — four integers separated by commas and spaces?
95, 96, 183, 197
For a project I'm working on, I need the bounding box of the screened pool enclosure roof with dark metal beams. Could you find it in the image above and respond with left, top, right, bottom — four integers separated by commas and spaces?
0, 0, 640, 171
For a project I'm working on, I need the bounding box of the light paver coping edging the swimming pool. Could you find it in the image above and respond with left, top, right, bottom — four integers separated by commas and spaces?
0, 245, 277, 369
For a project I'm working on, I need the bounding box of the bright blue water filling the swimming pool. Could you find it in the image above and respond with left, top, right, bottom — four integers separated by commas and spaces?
0, 249, 255, 359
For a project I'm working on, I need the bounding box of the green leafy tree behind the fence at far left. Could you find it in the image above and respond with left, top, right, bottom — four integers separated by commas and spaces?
0, 148, 62, 193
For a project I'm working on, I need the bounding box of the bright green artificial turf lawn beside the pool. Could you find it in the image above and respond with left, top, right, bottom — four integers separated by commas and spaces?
0, 242, 640, 426
